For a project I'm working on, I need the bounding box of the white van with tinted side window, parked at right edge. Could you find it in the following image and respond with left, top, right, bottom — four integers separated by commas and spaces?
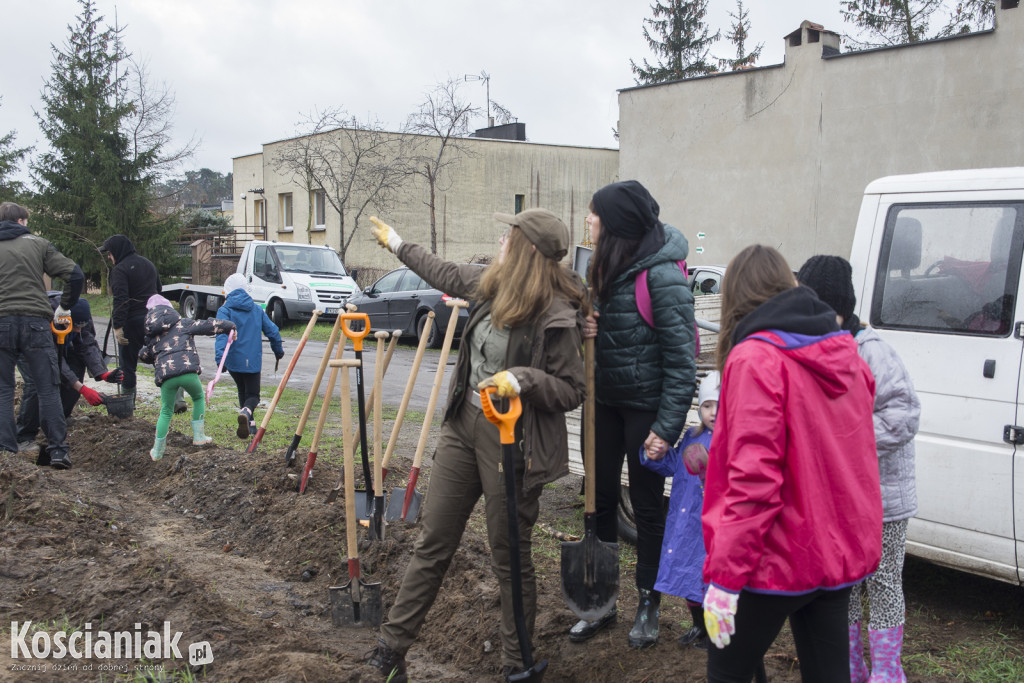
850, 168, 1024, 585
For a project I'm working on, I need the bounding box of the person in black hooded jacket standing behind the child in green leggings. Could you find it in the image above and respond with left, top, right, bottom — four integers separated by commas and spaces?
99, 234, 162, 394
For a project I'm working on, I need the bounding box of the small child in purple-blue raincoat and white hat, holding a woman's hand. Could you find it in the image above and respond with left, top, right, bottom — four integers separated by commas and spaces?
640, 372, 721, 650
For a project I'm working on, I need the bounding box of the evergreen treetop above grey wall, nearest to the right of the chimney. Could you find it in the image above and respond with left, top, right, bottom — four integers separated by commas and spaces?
840, 0, 945, 49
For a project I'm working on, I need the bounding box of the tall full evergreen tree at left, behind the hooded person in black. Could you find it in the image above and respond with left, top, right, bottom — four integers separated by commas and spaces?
32, 0, 177, 285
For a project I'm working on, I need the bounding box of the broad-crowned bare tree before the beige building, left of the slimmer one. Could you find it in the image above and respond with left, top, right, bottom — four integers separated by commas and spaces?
275, 109, 412, 260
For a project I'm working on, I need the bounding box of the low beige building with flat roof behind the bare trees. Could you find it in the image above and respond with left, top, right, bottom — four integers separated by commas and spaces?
233, 131, 618, 270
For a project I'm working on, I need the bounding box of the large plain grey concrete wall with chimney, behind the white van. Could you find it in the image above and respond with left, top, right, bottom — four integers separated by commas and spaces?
618, 0, 1024, 268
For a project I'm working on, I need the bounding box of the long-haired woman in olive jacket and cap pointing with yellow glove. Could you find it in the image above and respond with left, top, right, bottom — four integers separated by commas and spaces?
370, 209, 586, 681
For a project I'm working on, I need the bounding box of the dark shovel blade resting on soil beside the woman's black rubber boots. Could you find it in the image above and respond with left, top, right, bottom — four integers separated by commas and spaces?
562, 529, 618, 622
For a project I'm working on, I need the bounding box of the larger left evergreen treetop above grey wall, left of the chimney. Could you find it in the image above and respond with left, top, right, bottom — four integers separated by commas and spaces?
630, 0, 721, 85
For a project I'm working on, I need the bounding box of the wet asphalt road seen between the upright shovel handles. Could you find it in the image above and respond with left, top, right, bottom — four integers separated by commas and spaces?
93, 316, 458, 418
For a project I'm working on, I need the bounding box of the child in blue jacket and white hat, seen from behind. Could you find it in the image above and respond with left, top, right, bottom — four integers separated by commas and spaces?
214, 272, 285, 438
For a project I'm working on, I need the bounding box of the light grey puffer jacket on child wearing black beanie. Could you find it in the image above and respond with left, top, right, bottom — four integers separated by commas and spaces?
856, 328, 921, 522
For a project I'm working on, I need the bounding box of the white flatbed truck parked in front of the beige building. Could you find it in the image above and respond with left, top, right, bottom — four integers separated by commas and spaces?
163, 240, 358, 327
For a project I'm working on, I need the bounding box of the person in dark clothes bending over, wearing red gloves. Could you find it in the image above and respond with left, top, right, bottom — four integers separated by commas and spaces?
17, 294, 122, 453
